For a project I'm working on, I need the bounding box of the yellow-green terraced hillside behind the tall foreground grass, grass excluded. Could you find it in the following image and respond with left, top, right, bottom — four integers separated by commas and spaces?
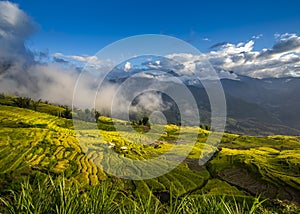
0, 96, 300, 210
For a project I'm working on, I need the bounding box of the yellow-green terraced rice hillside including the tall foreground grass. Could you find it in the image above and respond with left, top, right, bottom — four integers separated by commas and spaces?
0, 95, 300, 213
